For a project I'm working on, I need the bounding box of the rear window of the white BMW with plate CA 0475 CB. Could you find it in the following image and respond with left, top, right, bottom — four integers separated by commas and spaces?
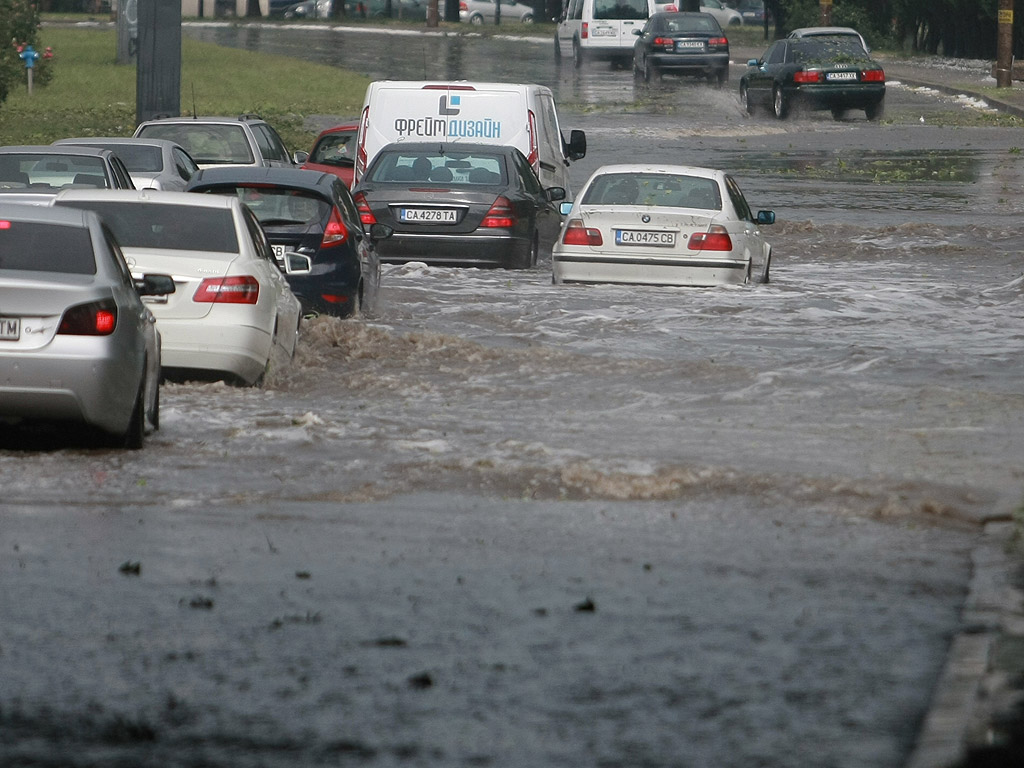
583, 173, 722, 211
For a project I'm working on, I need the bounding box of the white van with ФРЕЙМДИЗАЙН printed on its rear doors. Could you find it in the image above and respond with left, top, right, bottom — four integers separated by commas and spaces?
353, 80, 587, 195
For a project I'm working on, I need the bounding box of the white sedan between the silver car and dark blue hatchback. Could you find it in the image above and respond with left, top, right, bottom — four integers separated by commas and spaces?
54, 189, 309, 385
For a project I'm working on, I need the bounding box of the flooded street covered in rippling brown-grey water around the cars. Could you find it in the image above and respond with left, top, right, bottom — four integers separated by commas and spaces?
0, 22, 1024, 768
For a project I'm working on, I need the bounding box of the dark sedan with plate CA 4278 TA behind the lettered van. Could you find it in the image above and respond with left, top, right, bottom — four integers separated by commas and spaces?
353, 142, 565, 269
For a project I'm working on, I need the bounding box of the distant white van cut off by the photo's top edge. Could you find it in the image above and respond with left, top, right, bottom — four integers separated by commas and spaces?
555, 0, 656, 67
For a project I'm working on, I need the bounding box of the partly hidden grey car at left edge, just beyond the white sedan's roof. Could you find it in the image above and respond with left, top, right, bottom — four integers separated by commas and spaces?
0, 144, 135, 205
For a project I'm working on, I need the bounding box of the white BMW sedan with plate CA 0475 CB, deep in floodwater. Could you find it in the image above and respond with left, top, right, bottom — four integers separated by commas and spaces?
551, 165, 775, 286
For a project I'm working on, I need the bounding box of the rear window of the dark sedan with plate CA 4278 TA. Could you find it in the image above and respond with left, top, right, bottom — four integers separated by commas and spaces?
368, 151, 507, 185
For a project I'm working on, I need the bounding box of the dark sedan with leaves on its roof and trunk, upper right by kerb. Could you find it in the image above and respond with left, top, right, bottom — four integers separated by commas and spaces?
739, 37, 886, 120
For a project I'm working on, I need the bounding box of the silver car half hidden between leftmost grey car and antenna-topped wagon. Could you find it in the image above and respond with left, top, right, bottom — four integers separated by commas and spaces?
53, 136, 199, 191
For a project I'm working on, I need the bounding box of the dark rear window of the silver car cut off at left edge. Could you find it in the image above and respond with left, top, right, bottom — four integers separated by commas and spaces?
0, 219, 96, 274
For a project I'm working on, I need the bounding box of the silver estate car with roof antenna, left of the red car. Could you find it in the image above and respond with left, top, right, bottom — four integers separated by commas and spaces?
135, 115, 306, 168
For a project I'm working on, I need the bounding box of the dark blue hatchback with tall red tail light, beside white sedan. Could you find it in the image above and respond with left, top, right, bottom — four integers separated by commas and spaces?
185, 166, 390, 316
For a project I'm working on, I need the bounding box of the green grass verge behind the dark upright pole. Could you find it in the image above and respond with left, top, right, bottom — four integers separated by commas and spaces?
0, 27, 370, 151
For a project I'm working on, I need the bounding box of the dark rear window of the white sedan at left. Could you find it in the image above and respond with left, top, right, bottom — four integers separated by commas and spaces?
61, 200, 239, 253
